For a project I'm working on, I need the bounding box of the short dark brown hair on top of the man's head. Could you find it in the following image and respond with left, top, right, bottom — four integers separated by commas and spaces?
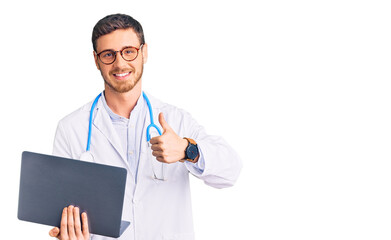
92, 13, 145, 52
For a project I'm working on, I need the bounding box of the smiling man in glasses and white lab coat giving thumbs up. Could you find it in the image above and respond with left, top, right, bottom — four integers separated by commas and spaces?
49, 14, 241, 240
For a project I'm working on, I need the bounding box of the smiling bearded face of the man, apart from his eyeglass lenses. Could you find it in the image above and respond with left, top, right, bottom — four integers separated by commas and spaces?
94, 29, 147, 93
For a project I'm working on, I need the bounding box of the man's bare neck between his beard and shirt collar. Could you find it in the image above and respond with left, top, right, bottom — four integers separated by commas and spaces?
105, 81, 141, 119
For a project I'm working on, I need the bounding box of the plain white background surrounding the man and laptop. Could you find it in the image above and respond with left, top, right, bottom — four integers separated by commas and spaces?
0, 0, 391, 240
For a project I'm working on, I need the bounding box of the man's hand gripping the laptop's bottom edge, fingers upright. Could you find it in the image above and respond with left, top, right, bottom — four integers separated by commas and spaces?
49, 205, 90, 240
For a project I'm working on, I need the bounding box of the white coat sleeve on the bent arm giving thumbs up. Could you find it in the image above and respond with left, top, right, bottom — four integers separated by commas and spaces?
172, 109, 242, 188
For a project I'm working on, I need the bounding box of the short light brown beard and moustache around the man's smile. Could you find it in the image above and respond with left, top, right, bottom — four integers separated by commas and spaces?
100, 65, 144, 93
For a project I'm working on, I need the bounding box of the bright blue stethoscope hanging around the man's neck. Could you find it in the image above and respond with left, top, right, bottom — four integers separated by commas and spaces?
80, 92, 164, 171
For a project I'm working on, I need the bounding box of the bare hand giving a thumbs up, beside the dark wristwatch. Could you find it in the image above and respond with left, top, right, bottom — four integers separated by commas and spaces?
150, 113, 188, 163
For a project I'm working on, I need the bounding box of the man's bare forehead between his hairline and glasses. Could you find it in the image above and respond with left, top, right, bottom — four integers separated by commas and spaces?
96, 28, 140, 53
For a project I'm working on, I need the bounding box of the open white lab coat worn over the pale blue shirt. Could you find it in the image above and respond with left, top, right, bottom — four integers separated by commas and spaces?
53, 92, 241, 240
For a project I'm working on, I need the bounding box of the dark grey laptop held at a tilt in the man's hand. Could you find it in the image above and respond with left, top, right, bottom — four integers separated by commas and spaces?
18, 152, 130, 238
